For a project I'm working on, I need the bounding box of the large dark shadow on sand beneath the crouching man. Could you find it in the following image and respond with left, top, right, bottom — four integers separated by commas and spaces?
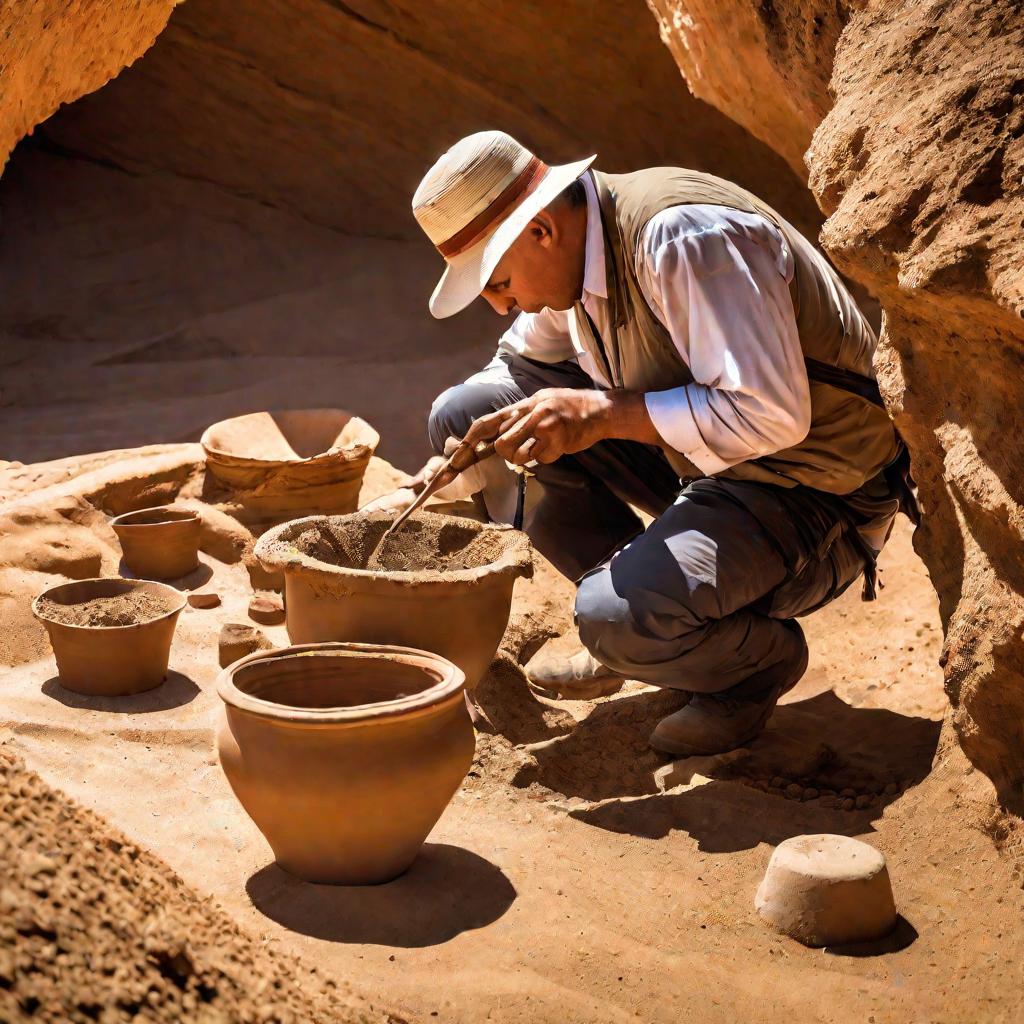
515, 691, 940, 853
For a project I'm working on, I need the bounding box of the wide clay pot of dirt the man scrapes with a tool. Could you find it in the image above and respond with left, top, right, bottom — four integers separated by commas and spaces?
254, 512, 532, 689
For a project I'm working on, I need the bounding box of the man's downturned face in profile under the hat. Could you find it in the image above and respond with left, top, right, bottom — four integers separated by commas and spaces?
481, 209, 585, 315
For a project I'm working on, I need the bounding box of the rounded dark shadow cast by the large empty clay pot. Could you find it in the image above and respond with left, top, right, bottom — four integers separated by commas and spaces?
246, 843, 516, 947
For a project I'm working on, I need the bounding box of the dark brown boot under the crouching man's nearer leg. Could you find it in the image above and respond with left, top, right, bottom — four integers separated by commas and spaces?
650, 623, 807, 758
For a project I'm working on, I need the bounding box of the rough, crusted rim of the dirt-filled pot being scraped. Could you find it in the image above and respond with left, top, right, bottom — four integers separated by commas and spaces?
253, 509, 532, 588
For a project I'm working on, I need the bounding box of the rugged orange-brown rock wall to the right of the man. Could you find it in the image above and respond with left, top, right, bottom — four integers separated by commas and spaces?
651, 0, 1024, 813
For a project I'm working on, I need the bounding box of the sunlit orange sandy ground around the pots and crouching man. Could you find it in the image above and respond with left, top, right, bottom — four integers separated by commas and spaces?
0, 445, 1024, 1024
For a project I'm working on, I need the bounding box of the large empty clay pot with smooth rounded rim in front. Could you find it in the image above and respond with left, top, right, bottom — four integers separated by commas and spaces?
217, 643, 474, 885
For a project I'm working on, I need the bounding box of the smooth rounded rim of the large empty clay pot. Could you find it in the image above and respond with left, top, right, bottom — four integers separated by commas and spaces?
217, 640, 466, 725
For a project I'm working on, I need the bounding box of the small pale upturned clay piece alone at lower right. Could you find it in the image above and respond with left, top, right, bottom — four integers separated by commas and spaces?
754, 835, 896, 946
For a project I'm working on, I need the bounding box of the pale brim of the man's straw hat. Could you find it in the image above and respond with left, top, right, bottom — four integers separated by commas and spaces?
430, 157, 597, 319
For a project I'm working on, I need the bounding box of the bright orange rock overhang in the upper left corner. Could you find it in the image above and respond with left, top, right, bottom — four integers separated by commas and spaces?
0, 0, 179, 169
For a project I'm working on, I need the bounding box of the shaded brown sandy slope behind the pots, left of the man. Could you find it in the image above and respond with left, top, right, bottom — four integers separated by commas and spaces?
0, 142, 495, 466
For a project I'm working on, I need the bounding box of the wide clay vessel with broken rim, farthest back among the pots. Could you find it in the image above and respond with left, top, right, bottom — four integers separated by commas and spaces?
201, 409, 380, 521
